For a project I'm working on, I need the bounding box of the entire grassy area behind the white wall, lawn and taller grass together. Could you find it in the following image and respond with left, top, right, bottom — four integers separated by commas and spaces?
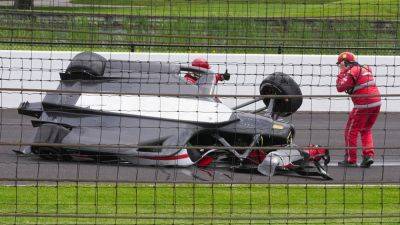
0, 0, 400, 55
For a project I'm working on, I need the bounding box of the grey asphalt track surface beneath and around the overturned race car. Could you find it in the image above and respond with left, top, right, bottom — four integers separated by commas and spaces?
0, 109, 400, 185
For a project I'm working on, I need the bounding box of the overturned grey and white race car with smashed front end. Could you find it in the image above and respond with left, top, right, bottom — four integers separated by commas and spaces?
16, 52, 331, 179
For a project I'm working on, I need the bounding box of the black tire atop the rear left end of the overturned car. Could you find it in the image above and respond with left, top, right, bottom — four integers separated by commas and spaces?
62, 52, 107, 80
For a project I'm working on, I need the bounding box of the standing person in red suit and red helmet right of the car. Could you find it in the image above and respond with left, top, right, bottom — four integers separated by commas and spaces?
336, 52, 381, 168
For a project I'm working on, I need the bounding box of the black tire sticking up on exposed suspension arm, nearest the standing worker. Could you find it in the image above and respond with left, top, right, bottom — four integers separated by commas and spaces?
260, 72, 303, 117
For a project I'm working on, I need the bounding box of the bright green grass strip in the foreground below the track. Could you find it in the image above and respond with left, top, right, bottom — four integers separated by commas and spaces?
0, 184, 400, 224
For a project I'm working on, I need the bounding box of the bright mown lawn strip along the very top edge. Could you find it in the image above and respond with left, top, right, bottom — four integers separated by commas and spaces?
58, 0, 399, 19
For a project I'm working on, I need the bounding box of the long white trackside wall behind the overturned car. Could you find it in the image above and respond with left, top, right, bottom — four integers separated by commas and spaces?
0, 50, 400, 112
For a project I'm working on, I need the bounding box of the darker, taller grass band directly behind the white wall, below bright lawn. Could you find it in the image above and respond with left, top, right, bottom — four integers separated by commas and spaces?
0, 12, 400, 55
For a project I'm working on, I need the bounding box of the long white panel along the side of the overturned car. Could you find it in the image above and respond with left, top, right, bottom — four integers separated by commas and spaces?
76, 94, 233, 123
